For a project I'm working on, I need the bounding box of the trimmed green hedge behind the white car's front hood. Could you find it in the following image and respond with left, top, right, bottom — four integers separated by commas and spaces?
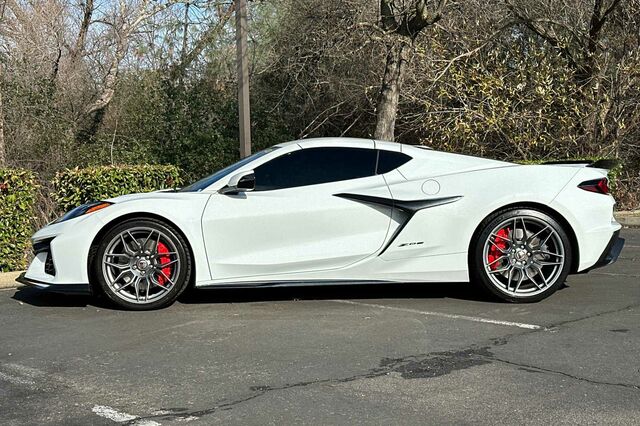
52, 165, 182, 211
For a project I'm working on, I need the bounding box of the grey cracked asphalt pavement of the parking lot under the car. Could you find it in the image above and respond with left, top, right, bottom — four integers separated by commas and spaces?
0, 229, 640, 426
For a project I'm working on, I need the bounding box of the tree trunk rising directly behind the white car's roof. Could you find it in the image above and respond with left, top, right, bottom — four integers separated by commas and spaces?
374, 39, 411, 141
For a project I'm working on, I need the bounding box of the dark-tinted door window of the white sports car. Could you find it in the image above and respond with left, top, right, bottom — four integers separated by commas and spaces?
254, 147, 377, 191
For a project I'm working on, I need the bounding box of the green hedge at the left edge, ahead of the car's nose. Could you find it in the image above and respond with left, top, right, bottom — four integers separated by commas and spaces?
0, 168, 38, 272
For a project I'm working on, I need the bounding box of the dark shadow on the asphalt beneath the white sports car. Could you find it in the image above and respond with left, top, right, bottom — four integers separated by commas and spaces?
12, 283, 498, 310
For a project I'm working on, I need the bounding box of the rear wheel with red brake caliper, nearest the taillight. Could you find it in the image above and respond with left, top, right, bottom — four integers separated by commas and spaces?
469, 207, 572, 303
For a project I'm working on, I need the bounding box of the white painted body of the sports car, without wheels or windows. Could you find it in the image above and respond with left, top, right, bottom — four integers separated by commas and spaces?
23, 138, 620, 292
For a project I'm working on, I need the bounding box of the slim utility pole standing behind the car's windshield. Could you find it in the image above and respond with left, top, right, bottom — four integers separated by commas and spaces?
235, 0, 251, 158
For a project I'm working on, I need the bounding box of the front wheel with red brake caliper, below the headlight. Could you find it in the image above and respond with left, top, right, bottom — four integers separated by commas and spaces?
93, 219, 192, 310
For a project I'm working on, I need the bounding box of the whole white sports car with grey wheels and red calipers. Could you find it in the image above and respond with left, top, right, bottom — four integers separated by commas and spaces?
20, 138, 624, 310
